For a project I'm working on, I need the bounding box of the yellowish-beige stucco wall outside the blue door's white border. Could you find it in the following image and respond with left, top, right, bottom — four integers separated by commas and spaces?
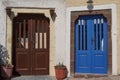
66, 0, 120, 74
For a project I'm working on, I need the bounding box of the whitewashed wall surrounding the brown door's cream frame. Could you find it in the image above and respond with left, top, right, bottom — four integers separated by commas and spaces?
0, 0, 66, 63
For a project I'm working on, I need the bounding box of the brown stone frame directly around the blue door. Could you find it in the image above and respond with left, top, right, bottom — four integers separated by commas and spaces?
70, 9, 112, 76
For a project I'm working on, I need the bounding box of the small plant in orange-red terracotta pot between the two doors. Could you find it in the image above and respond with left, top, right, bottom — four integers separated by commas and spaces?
55, 63, 67, 80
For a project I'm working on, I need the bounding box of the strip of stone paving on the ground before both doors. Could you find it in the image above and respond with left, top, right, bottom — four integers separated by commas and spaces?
11, 76, 120, 80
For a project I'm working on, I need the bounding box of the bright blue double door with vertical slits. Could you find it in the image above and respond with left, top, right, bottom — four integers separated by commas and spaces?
75, 15, 107, 74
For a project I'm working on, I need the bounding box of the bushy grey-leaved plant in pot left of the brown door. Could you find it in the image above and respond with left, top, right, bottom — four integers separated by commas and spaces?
0, 45, 13, 79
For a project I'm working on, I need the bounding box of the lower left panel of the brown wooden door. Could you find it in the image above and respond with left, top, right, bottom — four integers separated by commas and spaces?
16, 52, 31, 74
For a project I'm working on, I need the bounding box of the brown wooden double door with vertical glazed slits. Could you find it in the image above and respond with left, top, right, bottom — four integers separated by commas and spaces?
13, 14, 49, 75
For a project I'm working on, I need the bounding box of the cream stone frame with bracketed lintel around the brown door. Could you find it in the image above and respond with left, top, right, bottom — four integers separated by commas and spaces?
6, 7, 56, 76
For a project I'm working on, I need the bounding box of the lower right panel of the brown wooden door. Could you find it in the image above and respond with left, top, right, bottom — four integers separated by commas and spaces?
33, 52, 49, 74
